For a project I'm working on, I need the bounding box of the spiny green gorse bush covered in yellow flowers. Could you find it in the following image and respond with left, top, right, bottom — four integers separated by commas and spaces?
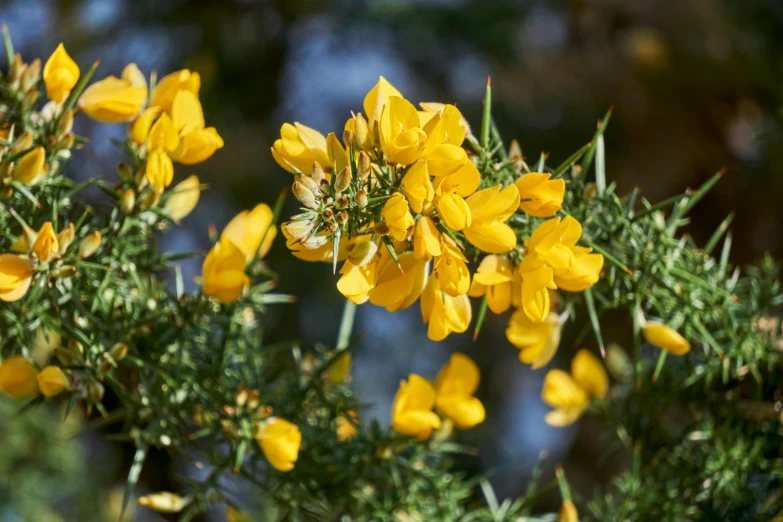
0, 32, 783, 521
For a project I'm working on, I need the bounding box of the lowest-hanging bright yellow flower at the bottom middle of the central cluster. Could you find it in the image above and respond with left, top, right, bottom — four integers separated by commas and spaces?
421, 277, 472, 341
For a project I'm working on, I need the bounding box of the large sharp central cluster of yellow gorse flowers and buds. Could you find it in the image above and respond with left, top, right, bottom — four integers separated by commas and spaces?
272, 77, 603, 354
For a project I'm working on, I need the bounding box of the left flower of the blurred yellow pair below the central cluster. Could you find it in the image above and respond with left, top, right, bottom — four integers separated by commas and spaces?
392, 373, 440, 440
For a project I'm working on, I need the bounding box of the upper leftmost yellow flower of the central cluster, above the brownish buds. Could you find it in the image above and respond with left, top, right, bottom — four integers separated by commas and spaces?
272, 123, 348, 173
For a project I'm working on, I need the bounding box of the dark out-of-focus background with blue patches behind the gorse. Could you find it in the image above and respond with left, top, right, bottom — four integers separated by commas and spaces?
0, 0, 783, 522
